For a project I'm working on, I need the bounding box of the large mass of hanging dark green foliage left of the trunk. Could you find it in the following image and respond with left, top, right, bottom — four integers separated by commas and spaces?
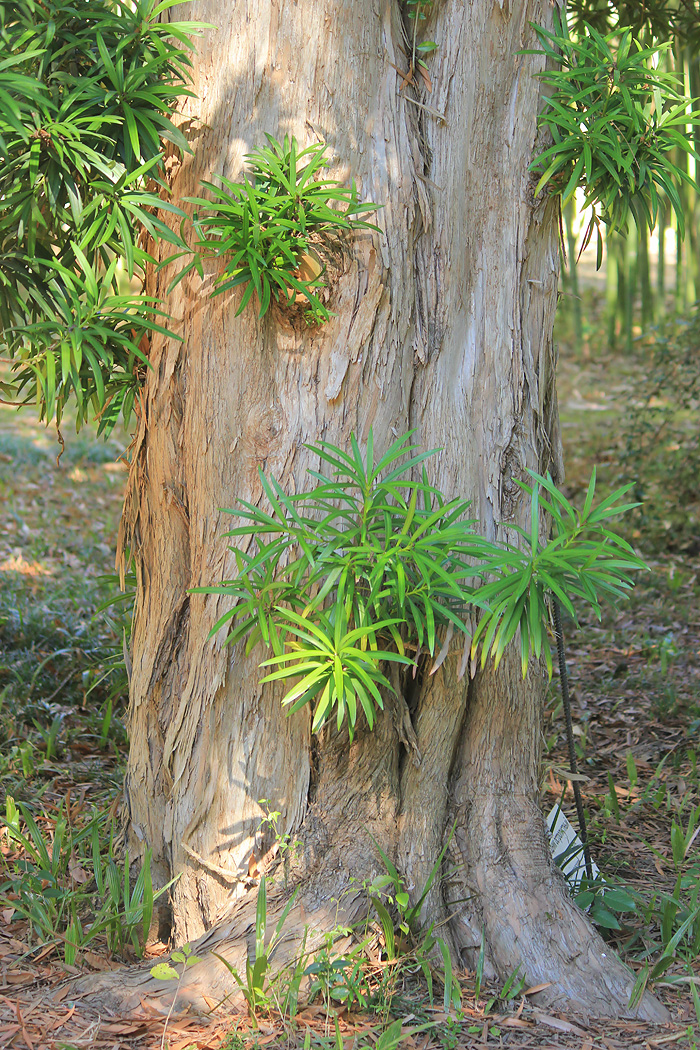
0, 0, 207, 431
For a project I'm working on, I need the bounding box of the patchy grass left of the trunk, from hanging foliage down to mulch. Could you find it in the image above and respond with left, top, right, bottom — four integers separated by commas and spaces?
0, 407, 131, 936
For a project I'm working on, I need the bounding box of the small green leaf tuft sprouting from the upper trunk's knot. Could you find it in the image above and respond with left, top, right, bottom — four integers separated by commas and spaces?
169, 134, 378, 322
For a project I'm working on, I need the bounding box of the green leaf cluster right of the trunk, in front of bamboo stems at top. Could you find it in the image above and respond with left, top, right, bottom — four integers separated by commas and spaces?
524, 19, 700, 265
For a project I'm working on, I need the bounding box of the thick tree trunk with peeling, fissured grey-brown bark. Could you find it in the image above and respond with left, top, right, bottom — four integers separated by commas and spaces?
85, 0, 663, 1019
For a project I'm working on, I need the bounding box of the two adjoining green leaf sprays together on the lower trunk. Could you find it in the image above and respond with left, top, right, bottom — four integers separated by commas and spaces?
197, 431, 643, 736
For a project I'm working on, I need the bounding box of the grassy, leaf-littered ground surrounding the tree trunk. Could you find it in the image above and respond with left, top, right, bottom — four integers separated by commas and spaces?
0, 275, 700, 1050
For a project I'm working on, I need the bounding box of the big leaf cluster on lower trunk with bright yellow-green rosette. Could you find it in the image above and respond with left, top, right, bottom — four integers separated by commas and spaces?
199, 432, 486, 733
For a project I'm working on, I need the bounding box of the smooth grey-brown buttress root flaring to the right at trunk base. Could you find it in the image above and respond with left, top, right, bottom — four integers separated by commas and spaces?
449, 659, 669, 1022
